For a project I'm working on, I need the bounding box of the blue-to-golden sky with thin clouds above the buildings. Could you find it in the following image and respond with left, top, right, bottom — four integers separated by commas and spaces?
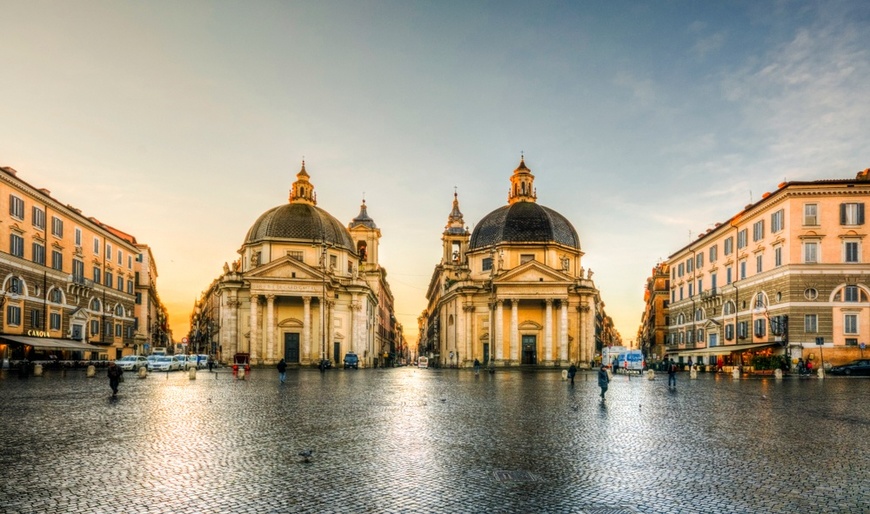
0, 0, 870, 342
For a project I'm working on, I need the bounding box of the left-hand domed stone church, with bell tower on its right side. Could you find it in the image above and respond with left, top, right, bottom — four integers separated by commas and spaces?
198, 161, 401, 367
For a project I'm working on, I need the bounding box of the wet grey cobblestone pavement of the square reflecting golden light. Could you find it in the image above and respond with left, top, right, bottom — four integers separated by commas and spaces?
0, 368, 870, 514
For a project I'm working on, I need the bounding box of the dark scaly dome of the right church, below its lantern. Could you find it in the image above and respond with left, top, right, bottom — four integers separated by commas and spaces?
469, 202, 580, 250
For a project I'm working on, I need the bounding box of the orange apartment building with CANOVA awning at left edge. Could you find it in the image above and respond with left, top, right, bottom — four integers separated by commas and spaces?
0, 167, 152, 360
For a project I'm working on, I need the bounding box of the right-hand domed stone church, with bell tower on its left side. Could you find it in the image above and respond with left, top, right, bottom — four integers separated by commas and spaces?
421, 158, 598, 367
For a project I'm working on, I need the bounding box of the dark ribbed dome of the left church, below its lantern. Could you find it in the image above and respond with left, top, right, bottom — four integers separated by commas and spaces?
245, 203, 356, 251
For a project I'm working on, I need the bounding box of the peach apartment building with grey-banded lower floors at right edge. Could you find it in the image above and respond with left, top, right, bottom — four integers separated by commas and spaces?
666, 170, 870, 368
